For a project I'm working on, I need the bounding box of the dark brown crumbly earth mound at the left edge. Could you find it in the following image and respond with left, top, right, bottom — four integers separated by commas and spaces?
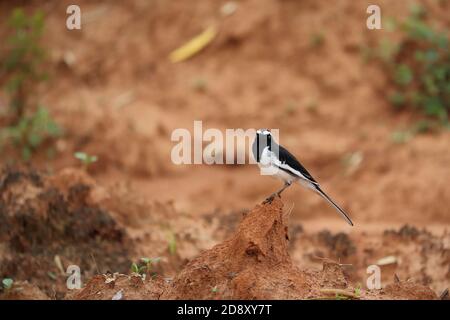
0, 169, 132, 298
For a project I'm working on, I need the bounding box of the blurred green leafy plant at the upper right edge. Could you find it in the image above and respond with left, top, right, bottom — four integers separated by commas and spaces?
374, 4, 450, 127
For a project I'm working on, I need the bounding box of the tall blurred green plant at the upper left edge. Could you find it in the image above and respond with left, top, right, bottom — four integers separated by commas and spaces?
0, 9, 62, 161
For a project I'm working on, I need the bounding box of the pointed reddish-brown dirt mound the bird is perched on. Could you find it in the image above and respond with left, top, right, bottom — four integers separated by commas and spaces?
162, 199, 320, 299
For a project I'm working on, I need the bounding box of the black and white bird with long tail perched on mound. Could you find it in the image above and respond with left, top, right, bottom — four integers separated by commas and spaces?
252, 129, 353, 226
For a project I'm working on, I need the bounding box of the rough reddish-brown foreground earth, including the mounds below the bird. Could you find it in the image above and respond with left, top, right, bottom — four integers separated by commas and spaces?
0, 169, 450, 299
